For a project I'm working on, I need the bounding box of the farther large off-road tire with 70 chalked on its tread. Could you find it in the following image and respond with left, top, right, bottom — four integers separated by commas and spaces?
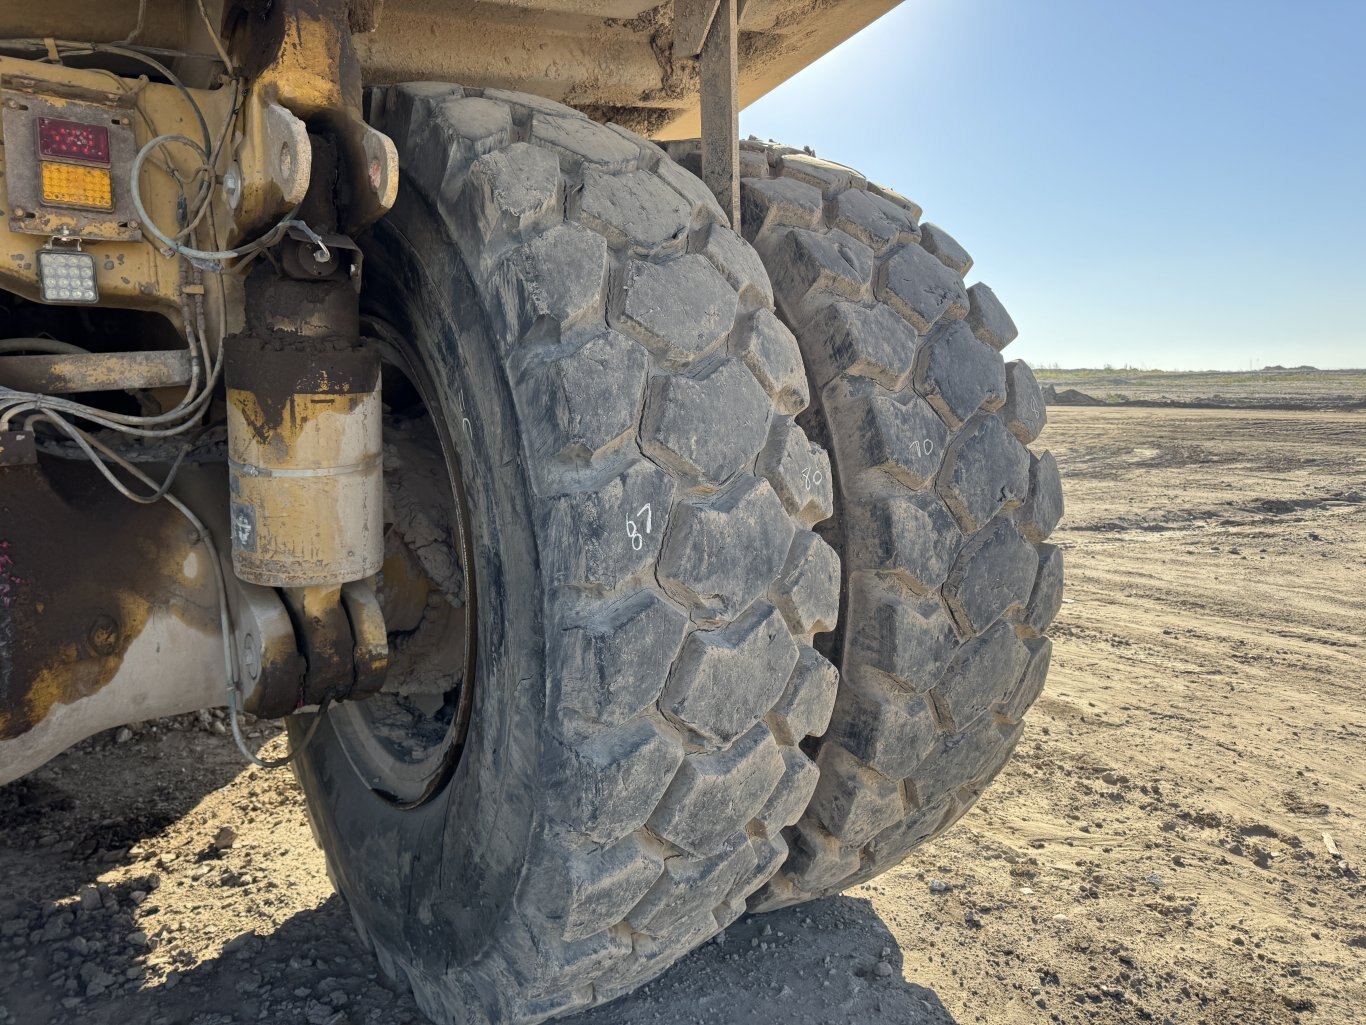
669, 142, 1063, 907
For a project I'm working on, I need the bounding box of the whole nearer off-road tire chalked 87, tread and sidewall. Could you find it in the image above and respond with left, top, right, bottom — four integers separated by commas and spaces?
286, 90, 839, 1022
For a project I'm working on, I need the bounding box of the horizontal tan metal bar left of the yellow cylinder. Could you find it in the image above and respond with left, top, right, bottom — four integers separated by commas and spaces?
0, 349, 190, 395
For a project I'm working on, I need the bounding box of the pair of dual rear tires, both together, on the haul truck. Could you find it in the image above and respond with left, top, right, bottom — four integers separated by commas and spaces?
291, 90, 1061, 1025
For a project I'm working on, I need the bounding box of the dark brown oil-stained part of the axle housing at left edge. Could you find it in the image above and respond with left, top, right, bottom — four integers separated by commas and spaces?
0, 459, 223, 754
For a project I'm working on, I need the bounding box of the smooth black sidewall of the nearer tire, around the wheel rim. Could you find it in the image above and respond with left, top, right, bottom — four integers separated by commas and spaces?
291, 190, 545, 976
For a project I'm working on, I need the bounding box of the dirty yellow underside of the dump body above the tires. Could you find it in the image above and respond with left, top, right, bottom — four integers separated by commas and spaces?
0, 0, 899, 139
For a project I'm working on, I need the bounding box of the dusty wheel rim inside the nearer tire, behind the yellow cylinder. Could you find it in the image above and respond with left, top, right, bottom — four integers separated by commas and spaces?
329, 318, 478, 808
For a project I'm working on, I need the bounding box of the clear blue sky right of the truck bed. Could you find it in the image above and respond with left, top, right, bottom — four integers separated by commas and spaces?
740, 0, 1366, 369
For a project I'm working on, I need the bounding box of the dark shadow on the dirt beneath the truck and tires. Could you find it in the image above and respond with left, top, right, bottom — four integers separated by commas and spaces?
0, 718, 955, 1025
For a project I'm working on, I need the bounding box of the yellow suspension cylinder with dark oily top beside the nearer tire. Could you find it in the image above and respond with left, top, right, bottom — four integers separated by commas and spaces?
224, 271, 384, 588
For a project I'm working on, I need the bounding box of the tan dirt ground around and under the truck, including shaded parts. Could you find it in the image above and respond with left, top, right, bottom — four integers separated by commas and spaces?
0, 409, 1366, 1025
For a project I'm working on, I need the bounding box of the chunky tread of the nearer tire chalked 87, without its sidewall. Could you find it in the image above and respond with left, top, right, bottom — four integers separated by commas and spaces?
330, 92, 839, 1025
